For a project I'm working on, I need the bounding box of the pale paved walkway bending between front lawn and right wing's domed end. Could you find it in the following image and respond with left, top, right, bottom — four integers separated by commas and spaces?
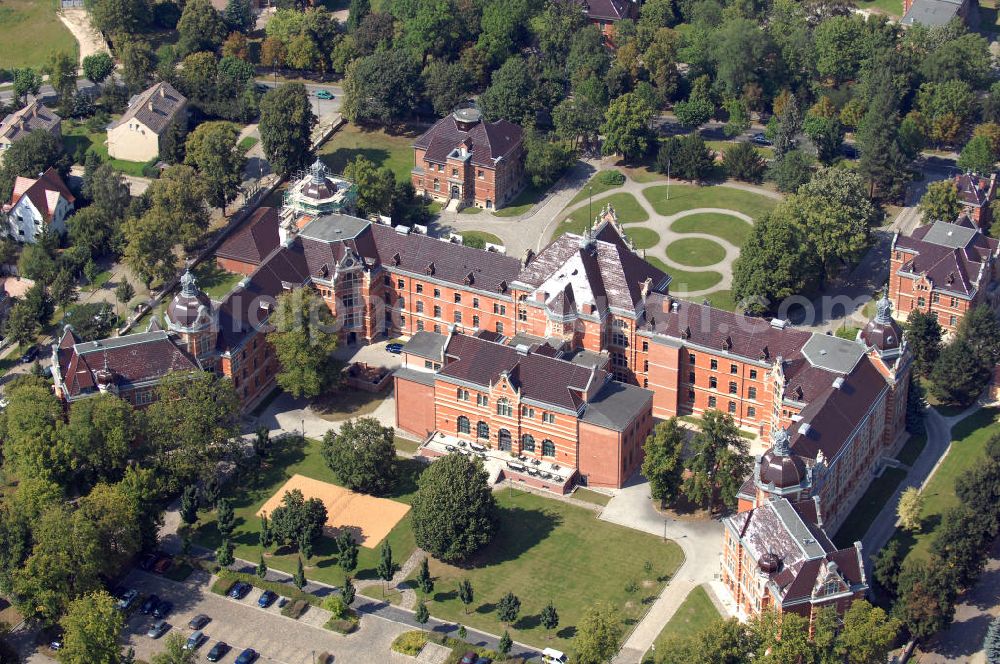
600, 475, 724, 664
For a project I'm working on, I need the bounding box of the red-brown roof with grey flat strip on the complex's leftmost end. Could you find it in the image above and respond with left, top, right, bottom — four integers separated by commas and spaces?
57, 331, 199, 397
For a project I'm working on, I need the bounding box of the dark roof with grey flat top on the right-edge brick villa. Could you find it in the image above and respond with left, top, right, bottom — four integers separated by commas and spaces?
894, 221, 1000, 297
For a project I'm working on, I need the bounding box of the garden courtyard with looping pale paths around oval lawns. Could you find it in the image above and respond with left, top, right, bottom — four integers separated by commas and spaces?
553, 169, 780, 310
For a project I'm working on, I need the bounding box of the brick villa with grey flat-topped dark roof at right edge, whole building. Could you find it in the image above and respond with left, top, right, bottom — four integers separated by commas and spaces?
889, 215, 1000, 332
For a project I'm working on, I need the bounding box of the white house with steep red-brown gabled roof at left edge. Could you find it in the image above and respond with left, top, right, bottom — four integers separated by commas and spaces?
3, 167, 76, 244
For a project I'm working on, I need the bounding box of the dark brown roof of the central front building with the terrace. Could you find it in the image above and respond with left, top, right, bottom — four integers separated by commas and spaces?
438, 334, 608, 411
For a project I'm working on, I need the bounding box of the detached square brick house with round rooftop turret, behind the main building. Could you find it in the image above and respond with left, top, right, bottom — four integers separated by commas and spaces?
410, 108, 524, 210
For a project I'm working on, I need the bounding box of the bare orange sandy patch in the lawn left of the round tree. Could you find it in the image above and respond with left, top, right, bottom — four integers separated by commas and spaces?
257, 475, 410, 549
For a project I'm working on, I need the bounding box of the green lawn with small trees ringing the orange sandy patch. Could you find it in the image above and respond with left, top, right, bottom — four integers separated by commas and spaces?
192, 437, 424, 586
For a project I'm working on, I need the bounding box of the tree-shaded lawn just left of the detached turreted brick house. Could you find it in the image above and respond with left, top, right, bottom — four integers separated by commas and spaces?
318, 124, 421, 182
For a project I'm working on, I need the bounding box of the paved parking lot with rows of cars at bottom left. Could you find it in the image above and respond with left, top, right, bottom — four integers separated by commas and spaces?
123, 570, 410, 664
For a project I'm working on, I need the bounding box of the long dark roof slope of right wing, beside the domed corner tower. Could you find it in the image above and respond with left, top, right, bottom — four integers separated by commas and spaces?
790, 355, 889, 463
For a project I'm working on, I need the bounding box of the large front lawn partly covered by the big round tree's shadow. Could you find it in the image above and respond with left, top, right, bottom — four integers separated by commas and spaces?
406, 490, 684, 650
